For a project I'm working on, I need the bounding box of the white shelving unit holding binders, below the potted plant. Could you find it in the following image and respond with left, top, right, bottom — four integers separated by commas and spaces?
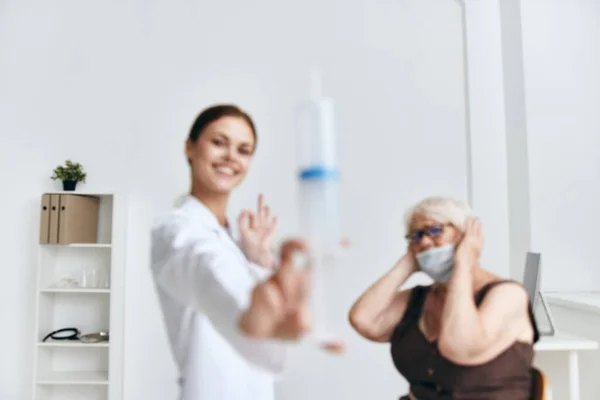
33, 191, 126, 400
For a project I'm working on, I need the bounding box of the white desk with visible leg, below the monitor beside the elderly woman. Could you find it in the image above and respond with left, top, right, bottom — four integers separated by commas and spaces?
534, 332, 598, 400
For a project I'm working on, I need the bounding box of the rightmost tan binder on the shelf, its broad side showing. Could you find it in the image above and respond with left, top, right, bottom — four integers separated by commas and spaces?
58, 194, 100, 244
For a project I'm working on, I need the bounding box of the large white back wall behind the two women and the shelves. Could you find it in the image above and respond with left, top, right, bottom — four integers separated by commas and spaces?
0, 0, 482, 400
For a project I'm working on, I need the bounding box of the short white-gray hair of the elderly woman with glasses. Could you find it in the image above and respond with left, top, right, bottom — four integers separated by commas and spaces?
404, 197, 472, 232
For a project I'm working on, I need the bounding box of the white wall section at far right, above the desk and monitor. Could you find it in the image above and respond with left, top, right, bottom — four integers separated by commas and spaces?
522, 0, 600, 291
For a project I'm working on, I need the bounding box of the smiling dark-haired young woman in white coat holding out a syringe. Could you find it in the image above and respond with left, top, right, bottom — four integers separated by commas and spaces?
151, 105, 309, 400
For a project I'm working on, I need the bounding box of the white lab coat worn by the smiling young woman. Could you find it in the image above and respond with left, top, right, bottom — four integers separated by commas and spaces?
151, 195, 286, 400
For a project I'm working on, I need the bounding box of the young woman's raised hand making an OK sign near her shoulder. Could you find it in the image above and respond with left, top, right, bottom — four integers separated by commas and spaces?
238, 194, 277, 268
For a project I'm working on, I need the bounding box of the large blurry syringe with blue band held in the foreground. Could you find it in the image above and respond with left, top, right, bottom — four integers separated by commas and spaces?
298, 69, 341, 347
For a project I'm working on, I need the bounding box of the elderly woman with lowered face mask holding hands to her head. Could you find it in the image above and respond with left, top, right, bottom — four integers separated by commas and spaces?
349, 198, 538, 400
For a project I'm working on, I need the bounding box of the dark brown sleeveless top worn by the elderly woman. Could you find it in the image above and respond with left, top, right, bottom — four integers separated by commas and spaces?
390, 281, 539, 400
